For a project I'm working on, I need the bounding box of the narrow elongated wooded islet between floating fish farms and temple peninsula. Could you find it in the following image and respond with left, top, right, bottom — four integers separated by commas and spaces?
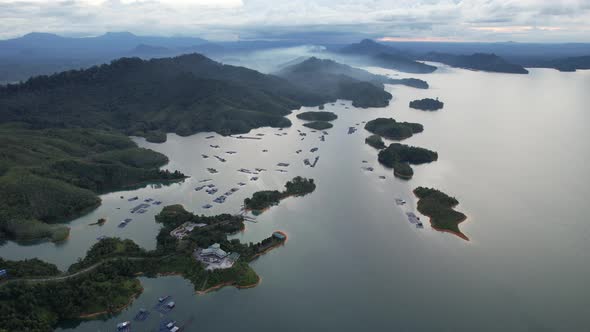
244, 176, 316, 213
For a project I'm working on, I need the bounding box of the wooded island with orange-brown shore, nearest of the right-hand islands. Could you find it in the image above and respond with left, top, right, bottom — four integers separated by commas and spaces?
414, 187, 469, 241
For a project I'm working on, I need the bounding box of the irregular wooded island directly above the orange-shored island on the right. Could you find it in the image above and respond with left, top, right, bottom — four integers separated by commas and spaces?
378, 143, 438, 180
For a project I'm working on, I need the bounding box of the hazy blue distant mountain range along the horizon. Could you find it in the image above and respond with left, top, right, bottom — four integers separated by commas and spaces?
0, 32, 590, 84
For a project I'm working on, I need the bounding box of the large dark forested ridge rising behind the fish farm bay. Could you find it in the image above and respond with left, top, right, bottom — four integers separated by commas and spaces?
0, 54, 328, 141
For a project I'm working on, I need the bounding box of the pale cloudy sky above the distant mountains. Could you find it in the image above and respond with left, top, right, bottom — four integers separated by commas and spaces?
0, 0, 590, 42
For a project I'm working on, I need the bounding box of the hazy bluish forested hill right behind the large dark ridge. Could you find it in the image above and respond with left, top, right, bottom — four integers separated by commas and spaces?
277, 58, 392, 107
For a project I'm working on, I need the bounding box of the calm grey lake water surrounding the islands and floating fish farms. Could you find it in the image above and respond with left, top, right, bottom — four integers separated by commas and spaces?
0, 64, 590, 331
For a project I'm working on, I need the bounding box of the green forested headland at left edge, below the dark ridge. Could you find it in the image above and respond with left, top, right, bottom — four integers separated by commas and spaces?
0, 124, 186, 241
